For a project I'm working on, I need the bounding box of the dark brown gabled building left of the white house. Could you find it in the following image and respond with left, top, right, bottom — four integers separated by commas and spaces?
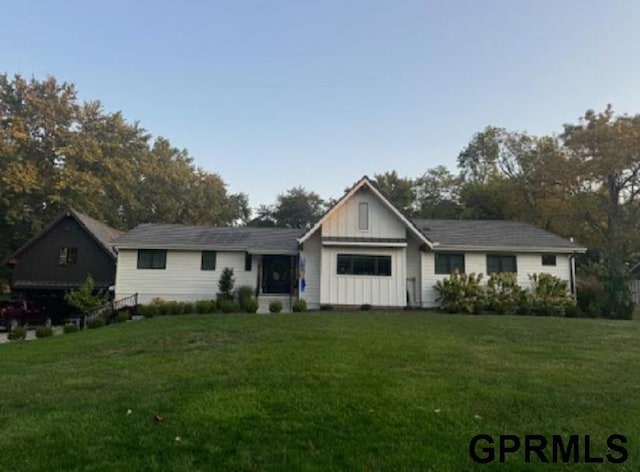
7, 209, 122, 319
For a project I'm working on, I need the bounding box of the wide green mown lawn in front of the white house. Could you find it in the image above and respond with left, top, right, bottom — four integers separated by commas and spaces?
0, 312, 640, 472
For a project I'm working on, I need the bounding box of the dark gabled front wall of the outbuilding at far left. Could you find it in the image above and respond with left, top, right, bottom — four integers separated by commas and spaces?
12, 216, 116, 287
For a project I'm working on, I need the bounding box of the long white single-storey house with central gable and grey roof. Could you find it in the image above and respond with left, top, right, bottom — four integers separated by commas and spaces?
115, 176, 585, 310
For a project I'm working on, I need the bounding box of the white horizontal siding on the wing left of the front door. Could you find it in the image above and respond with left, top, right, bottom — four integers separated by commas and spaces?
115, 249, 258, 304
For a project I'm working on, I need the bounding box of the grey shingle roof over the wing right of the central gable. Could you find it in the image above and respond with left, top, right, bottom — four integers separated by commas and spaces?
413, 220, 583, 252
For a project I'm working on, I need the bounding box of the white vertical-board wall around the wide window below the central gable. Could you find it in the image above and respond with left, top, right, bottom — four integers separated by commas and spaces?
320, 247, 407, 307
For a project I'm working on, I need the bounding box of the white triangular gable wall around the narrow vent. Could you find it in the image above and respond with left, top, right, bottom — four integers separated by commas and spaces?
322, 189, 406, 238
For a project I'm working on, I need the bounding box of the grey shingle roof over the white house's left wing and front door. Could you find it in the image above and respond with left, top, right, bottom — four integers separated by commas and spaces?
115, 223, 302, 255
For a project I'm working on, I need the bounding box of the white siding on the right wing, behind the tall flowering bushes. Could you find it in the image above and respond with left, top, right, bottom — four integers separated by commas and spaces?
422, 252, 571, 308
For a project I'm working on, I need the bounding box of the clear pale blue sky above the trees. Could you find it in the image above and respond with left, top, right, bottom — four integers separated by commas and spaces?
0, 0, 640, 207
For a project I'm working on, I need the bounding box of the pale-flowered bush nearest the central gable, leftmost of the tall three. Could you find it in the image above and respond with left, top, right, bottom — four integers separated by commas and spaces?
435, 271, 486, 314
